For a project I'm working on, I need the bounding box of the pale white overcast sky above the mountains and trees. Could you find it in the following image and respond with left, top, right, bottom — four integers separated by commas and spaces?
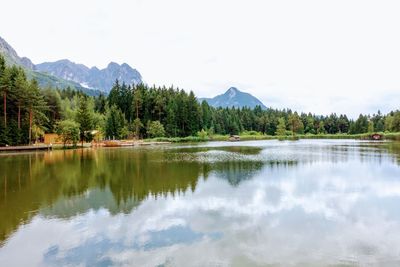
0, 0, 400, 117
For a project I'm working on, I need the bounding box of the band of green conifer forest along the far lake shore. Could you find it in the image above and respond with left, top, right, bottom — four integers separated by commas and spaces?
0, 56, 400, 145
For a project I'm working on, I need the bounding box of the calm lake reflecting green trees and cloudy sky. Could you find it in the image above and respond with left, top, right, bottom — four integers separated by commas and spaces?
0, 140, 400, 267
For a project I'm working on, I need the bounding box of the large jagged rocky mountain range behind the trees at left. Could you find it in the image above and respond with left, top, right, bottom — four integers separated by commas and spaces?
0, 37, 142, 95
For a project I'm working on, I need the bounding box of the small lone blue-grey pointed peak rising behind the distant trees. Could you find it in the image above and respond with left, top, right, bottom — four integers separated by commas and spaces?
199, 87, 267, 109
